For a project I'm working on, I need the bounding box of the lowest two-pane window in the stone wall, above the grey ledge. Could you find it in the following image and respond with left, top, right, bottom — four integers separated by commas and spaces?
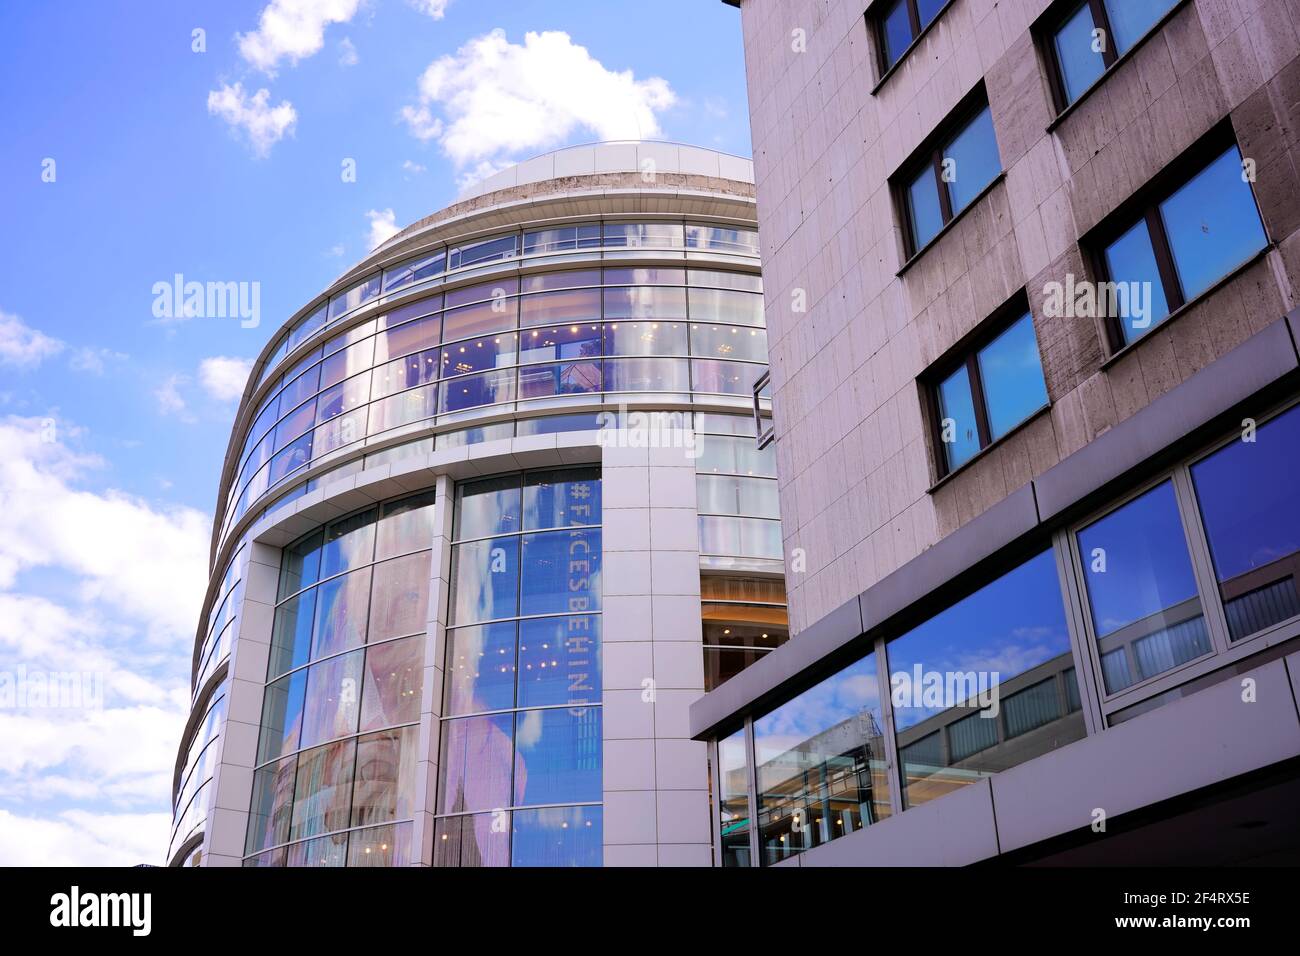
935, 307, 1048, 473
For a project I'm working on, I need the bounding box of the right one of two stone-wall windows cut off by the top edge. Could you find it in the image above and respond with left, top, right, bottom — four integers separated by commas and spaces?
1043, 0, 1177, 111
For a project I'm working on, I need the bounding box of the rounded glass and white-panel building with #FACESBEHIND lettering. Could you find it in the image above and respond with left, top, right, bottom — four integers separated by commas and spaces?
168, 143, 788, 866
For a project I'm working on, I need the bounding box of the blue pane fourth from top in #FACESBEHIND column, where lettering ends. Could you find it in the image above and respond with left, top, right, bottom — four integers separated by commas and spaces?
515, 708, 602, 806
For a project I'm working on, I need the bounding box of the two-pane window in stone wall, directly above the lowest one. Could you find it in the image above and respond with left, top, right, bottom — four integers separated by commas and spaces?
894, 90, 1002, 259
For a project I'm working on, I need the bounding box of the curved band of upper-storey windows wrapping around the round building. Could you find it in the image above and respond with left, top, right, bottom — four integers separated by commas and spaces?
226, 267, 767, 548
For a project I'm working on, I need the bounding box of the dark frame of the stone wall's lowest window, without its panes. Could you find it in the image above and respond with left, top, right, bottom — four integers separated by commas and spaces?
920, 289, 1052, 481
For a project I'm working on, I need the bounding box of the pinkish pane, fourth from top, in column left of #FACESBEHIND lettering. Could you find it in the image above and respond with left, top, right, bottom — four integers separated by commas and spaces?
438, 714, 517, 813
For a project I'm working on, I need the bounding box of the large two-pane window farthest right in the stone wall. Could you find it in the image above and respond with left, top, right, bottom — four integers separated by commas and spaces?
1096, 143, 1269, 350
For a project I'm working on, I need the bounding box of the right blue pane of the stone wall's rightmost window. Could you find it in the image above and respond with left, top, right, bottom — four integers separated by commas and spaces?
1160, 146, 1268, 300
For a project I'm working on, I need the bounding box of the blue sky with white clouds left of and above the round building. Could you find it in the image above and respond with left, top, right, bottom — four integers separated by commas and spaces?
0, 0, 750, 864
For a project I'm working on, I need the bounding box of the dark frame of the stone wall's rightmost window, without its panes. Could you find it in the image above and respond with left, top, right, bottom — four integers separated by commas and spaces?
1079, 116, 1273, 359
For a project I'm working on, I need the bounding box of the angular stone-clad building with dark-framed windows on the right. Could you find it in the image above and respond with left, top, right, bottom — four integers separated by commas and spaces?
690, 0, 1300, 866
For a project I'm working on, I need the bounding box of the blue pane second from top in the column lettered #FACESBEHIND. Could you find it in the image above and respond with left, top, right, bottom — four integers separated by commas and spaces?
519, 528, 601, 615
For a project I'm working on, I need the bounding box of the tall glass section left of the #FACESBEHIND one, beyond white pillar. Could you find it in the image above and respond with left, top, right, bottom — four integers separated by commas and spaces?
244, 492, 433, 866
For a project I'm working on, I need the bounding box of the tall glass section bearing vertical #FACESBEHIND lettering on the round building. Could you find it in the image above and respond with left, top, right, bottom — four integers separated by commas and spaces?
433, 468, 602, 866
